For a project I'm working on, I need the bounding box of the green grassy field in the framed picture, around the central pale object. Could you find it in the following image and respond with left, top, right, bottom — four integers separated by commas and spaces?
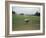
12, 15, 40, 31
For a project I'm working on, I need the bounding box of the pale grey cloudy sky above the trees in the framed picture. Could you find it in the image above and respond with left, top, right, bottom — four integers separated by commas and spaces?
12, 6, 40, 14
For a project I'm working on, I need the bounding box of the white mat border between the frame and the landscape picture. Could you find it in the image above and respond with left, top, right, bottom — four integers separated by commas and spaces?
9, 4, 43, 34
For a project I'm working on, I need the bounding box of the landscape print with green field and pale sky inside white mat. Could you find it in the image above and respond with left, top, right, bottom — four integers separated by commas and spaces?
12, 5, 41, 31
